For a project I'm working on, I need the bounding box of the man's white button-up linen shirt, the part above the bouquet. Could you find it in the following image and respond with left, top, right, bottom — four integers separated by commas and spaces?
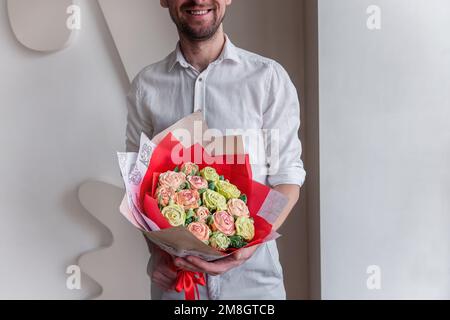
126, 37, 306, 187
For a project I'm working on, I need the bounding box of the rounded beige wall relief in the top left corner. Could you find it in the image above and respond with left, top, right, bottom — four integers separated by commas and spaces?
7, 0, 81, 52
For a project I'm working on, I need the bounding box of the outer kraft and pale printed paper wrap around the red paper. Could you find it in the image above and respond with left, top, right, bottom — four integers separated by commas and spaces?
118, 112, 287, 261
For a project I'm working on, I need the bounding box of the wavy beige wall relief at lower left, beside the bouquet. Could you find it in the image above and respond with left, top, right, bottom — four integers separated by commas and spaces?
78, 181, 150, 300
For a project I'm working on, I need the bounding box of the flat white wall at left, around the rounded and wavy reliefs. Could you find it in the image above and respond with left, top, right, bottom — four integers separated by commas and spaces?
0, 0, 134, 299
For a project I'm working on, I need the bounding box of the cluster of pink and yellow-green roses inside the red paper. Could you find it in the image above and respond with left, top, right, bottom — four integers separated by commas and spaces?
156, 162, 255, 251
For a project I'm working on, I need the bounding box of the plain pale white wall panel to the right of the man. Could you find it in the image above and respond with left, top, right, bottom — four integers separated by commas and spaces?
319, 0, 450, 299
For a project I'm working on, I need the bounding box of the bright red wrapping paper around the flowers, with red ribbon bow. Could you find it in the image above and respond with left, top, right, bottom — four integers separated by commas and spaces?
139, 133, 272, 300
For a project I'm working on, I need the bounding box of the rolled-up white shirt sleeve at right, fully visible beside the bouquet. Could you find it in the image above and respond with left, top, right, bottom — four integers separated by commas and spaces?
263, 62, 306, 187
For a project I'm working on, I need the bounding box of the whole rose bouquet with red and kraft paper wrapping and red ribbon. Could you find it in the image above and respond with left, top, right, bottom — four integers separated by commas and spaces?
118, 113, 287, 300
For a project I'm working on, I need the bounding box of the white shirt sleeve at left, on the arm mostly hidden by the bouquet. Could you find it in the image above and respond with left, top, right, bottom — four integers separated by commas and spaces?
126, 77, 153, 152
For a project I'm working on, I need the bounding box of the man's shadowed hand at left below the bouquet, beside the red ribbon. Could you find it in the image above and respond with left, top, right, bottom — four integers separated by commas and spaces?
150, 246, 177, 291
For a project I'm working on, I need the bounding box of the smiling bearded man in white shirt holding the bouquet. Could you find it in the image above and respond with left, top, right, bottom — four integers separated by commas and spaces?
127, 0, 305, 299
